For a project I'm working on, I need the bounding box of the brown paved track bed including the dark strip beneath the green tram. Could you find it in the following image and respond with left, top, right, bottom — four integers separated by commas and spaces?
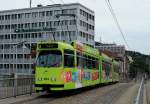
11, 83, 132, 104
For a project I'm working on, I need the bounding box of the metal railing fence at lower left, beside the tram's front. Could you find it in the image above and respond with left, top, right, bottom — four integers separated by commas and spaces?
0, 77, 34, 99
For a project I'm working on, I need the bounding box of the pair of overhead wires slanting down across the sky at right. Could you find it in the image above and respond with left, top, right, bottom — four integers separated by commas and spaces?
105, 0, 130, 48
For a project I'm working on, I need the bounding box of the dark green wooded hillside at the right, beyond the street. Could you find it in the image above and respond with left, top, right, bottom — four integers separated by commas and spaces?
126, 51, 150, 78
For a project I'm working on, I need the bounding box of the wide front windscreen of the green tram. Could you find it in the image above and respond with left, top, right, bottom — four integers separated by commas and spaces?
36, 50, 62, 67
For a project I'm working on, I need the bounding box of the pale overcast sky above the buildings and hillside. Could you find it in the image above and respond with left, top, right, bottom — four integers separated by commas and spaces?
0, 0, 150, 54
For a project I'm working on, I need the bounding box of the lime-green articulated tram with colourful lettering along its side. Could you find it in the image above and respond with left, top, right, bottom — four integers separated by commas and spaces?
35, 42, 119, 92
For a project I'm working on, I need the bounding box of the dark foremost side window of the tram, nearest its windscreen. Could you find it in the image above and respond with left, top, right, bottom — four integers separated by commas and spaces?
64, 50, 74, 67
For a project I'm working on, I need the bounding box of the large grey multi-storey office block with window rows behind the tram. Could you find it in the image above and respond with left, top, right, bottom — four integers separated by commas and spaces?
0, 3, 95, 75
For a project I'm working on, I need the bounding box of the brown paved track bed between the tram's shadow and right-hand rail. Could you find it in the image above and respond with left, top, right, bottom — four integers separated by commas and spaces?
44, 84, 131, 104
